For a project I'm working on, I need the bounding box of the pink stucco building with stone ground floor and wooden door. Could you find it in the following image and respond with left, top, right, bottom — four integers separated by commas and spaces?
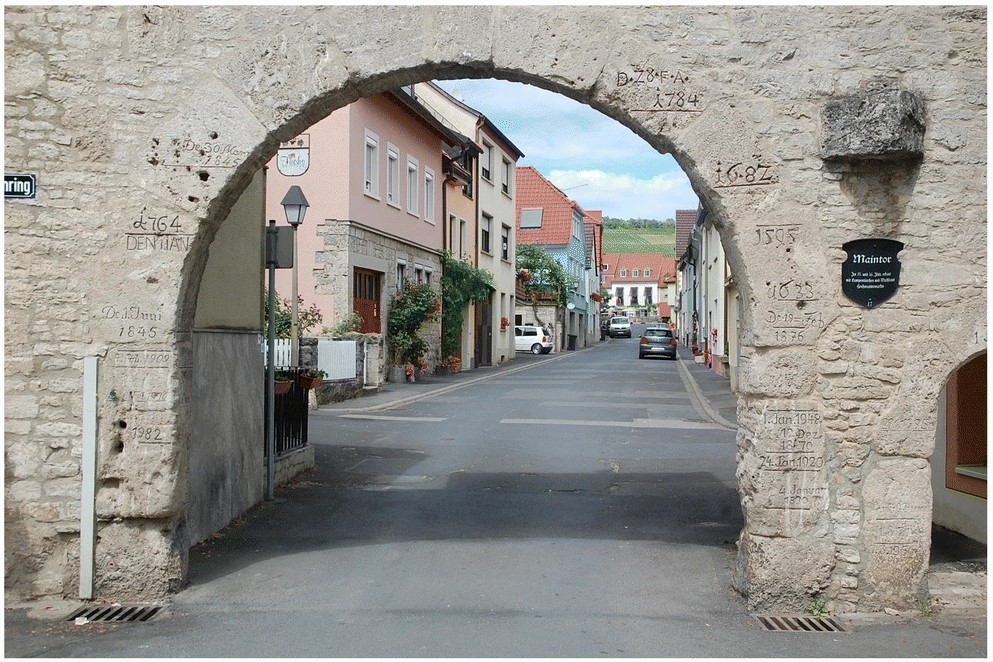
266, 90, 459, 362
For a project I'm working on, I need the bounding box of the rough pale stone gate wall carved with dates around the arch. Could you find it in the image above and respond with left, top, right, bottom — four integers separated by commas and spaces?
4, 6, 987, 611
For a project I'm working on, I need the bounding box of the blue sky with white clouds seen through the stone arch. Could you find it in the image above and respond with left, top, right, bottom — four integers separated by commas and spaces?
438, 80, 697, 220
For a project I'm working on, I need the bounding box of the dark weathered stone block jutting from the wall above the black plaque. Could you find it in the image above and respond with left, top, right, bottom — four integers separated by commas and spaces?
821, 89, 926, 161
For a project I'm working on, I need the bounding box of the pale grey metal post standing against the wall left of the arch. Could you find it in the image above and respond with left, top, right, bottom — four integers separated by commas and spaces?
79, 356, 97, 600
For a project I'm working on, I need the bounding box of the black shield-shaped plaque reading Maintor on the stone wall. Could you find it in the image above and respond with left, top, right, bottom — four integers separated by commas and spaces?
841, 239, 903, 308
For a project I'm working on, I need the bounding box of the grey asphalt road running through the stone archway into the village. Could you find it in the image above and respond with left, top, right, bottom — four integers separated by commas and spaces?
5, 336, 985, 657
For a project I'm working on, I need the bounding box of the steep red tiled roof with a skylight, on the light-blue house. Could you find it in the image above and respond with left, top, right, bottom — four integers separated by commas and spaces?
516, 166, 584, 246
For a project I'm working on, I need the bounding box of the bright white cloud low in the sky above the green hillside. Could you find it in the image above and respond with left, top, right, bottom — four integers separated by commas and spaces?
542, 170, 697, 220
